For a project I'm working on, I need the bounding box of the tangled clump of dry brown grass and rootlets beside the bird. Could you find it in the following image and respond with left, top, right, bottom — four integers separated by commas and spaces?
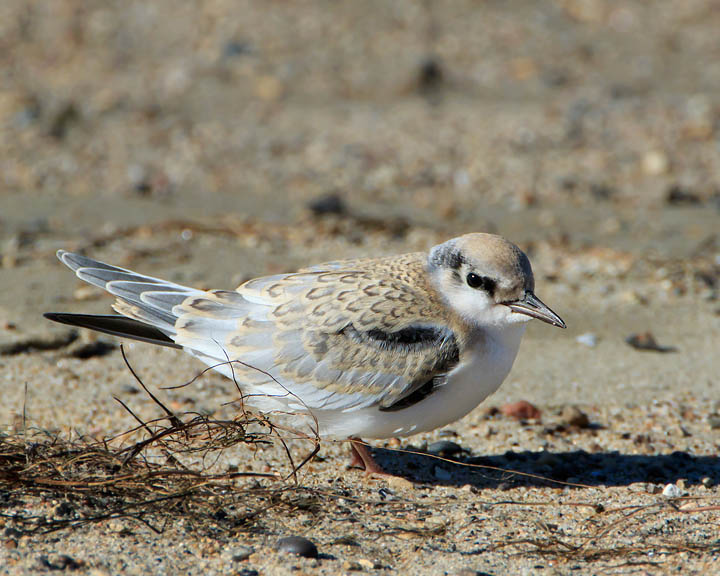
0, 352, 319, 534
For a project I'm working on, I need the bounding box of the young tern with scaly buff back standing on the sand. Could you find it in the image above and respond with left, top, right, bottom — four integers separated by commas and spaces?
45, 233, 566, 474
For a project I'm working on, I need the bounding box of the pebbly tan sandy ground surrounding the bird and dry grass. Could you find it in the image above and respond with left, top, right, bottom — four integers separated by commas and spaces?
0, 0, 720, 576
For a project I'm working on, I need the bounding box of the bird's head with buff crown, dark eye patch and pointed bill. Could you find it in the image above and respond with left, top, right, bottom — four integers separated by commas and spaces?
428, 233, 565, 328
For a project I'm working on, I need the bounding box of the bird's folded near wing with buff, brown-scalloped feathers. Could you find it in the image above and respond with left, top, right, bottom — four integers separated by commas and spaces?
174, 255, 459, 410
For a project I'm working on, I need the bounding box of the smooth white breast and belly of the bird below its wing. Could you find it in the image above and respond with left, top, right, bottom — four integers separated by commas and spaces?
315, 323, 526, 438
